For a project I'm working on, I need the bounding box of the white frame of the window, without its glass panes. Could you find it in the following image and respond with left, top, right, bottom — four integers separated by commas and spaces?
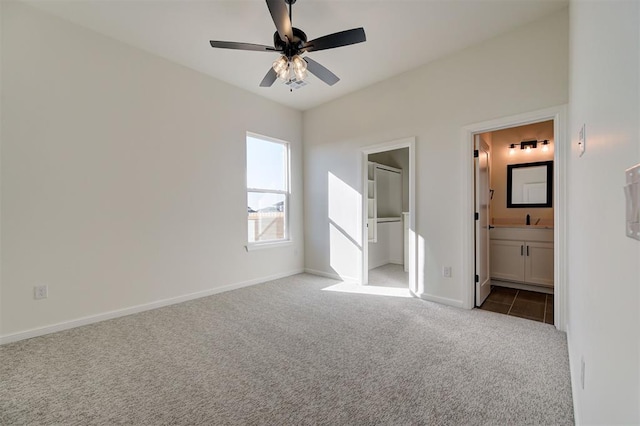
245, 132, 292, 251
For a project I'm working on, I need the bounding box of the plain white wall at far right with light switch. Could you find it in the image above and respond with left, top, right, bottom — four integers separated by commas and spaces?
567, 1, 640, 424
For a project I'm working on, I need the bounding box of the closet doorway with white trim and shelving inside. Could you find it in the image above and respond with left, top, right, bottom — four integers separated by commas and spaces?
362, 138, 416, 293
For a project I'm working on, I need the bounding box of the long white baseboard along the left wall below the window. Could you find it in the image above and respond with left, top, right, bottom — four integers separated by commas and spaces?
0, 269, 304, 345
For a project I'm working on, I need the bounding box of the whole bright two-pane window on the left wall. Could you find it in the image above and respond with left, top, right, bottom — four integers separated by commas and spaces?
247, 133, 289, 246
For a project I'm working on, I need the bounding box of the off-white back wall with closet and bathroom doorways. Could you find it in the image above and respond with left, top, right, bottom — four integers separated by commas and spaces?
303, 10, 568, 306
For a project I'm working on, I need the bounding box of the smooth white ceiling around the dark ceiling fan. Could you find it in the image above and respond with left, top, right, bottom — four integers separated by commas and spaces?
26, 0, 568, 110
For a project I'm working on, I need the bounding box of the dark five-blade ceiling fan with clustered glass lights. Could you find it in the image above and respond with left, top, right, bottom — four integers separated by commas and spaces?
210, 0, 367, 87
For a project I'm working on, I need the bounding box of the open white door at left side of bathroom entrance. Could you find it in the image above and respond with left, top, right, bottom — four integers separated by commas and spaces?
475, 135, 491, 306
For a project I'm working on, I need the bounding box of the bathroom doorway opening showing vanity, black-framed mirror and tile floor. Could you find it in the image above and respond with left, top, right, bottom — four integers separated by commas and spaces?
474, 120, 555, 323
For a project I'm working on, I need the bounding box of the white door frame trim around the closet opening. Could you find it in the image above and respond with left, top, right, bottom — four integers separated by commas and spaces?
360, 136, 417, 296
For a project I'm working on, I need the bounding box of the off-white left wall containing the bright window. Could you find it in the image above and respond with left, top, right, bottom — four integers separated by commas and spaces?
0, 2, 303, 340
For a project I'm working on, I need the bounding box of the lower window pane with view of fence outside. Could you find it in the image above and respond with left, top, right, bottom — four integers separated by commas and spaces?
247, 192, 286, 243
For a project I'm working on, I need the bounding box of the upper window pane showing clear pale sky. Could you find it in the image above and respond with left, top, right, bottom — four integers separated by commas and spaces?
247, 136, 287, 191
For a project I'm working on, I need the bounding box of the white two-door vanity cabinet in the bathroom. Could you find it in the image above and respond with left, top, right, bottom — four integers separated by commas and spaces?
490, 227, 553, 287
